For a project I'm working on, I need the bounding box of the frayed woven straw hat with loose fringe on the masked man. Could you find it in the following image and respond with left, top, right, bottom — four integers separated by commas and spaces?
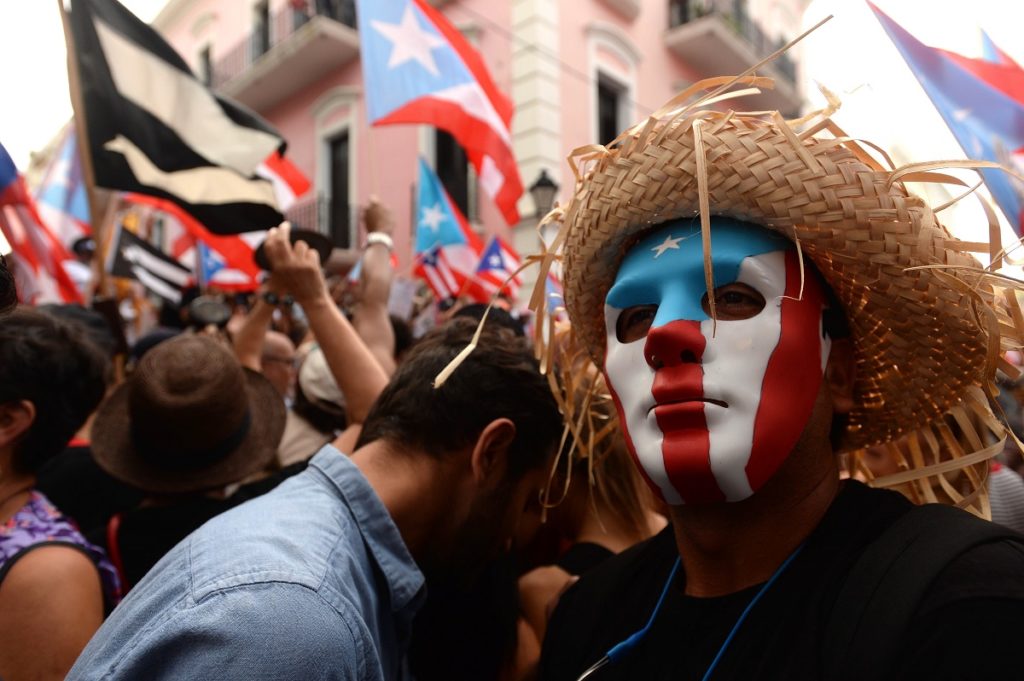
535, 78, 1024, 513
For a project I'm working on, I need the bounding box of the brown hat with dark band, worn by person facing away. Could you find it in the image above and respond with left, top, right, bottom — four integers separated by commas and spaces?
92, 335, 285, 494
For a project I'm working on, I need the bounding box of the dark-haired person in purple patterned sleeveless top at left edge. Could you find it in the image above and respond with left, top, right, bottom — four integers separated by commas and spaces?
0, 310, 119, 679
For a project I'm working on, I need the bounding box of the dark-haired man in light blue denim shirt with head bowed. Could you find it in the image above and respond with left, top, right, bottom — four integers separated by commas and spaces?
69, 321, 562, 681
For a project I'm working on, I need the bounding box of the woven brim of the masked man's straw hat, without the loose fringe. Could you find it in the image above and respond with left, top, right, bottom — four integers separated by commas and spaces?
563, 111, 1010, 449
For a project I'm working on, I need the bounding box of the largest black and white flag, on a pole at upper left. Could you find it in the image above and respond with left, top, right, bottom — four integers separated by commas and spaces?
71, 0, 285, 235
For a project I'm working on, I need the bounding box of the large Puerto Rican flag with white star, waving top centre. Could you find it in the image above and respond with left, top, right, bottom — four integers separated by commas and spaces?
356, 0, 522, 224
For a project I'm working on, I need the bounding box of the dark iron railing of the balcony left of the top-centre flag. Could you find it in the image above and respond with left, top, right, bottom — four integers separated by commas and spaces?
211, 0, 355, 87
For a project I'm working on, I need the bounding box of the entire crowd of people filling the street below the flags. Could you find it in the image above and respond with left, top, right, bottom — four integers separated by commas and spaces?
0, 80, 1024, 681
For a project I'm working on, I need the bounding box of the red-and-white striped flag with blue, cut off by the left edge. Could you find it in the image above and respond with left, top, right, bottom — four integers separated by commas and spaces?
0, 144, 82, 305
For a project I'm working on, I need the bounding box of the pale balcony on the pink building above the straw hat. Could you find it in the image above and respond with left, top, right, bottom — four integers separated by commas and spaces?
665, 0, 803, 116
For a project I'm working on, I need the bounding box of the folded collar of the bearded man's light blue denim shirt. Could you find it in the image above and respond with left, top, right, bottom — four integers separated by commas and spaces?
309, 444, 425, 612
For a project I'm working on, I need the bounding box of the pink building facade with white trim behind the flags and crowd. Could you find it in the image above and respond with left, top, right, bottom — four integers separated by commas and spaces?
154, 0, 806, 279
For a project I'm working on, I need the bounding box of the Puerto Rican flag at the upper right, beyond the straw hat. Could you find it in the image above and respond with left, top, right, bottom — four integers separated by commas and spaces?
868, 2, 1024, 235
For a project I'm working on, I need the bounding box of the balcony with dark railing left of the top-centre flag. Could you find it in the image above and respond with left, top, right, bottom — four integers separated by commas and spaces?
211, 0, 359, 112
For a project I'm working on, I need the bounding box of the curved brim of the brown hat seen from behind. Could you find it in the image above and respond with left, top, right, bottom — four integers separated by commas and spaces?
91, 369, 287, 494
